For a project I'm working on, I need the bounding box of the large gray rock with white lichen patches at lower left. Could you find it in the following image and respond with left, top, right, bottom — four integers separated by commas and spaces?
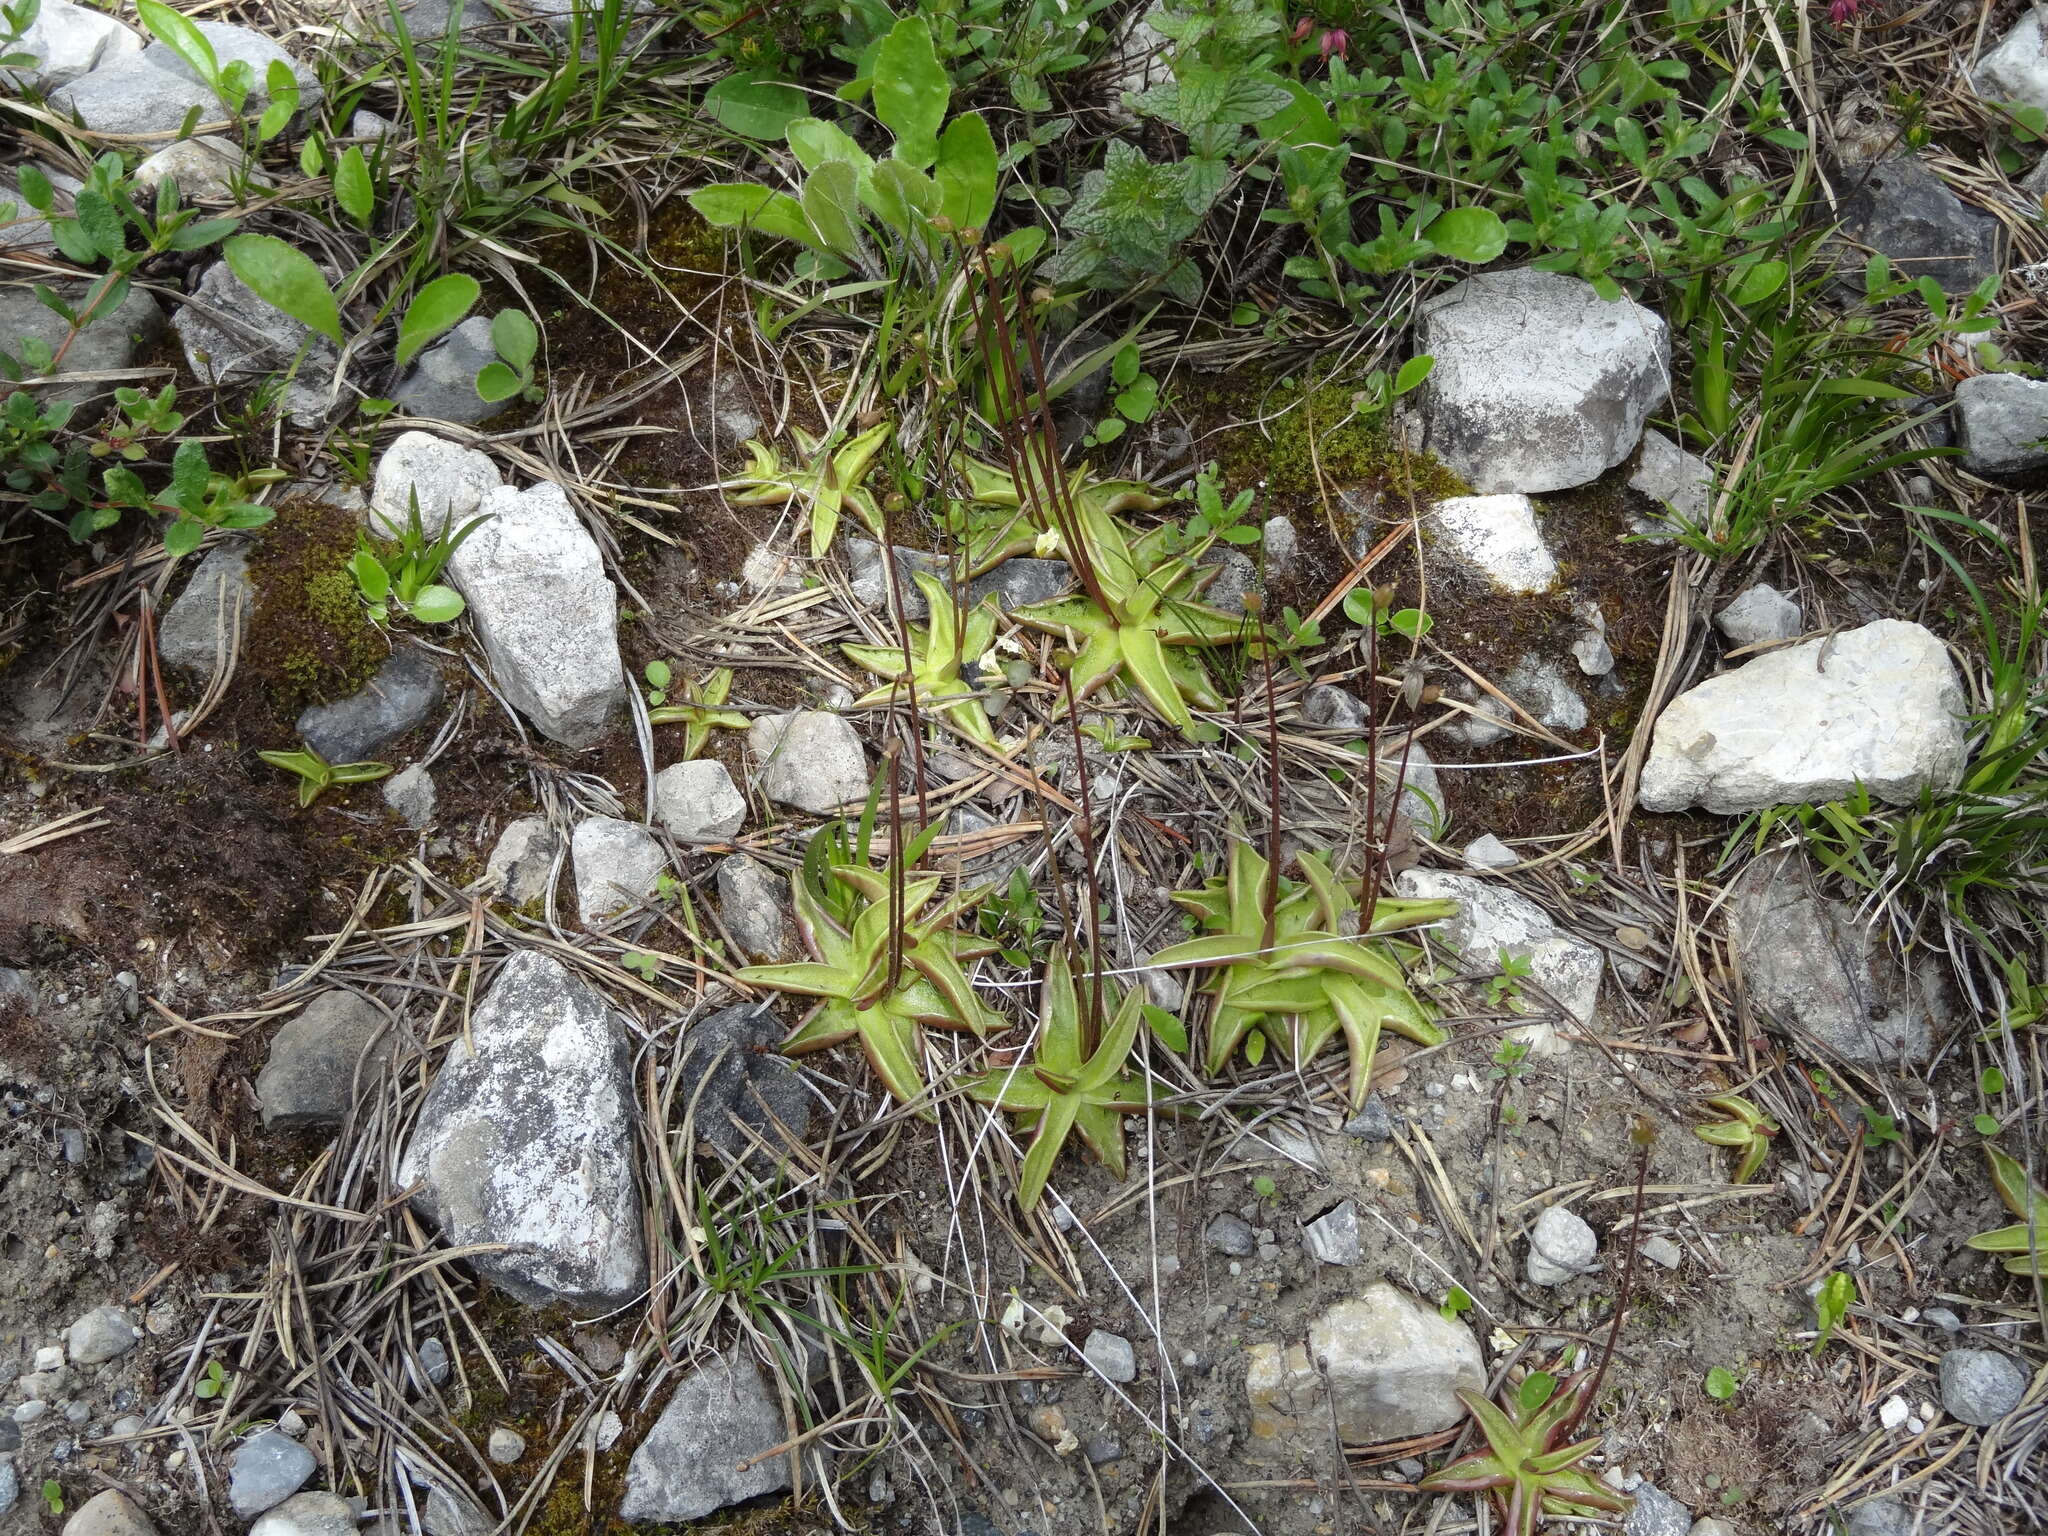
397, 950, 647, 1309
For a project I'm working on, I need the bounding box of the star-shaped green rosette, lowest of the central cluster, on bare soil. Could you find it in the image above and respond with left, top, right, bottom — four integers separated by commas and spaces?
967, 948, 1157, 1210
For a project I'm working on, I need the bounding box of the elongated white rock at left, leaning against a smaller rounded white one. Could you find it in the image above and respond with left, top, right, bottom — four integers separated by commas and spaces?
449, 481, 627, 748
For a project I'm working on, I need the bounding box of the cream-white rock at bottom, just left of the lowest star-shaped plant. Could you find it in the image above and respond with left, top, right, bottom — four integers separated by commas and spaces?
1245, 1280, 1487, 1456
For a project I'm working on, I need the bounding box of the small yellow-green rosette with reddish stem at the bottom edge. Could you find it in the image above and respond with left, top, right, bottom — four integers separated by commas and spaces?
1417, 1370, 1634, 1536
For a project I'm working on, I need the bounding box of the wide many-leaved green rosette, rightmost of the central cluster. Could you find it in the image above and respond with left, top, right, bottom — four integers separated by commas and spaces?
1153, 838, 1456, 1110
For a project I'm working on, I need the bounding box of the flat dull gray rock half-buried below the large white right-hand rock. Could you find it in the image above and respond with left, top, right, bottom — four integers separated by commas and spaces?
1729, 850, 1950, 1063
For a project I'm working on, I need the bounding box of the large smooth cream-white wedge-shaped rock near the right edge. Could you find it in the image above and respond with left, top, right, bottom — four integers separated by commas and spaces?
1638, 618, 1966, 815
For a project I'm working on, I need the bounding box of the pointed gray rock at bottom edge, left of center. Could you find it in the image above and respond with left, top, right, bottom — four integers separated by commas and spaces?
618, 1354, 791, 1524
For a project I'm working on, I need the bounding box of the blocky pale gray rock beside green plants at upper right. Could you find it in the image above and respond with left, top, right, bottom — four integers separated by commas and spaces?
1419, 268, 1671, 494
